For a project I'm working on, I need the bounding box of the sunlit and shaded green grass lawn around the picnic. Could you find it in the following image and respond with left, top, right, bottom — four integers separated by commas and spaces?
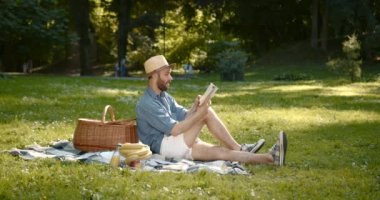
0, 63, 380, 199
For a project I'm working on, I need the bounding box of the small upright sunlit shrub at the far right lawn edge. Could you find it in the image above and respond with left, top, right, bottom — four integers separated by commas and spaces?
327, 34, 362, 82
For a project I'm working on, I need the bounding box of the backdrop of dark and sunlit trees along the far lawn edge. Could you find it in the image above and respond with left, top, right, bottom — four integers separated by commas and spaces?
0, 0, 380, 74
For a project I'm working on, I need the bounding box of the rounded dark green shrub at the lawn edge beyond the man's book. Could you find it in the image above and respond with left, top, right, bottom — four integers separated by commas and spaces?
216, 50, 248, 81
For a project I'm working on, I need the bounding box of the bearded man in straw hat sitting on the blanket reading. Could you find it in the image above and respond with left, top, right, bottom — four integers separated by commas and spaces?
136, 55, 287, 166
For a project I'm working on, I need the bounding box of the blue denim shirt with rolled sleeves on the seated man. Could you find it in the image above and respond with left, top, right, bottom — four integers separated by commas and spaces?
136, 87, 187, 153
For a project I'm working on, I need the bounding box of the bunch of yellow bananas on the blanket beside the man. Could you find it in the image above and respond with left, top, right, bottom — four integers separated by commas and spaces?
119, 143, 152, 163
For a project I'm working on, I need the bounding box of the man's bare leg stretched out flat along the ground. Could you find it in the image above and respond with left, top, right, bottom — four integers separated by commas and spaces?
192, 141, 273, 164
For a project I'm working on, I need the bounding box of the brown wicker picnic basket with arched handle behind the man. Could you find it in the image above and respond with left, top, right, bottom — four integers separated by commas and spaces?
73, 105, 138, 151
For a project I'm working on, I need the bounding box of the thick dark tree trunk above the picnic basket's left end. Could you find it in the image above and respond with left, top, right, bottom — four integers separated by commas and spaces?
71, 0, 92, 76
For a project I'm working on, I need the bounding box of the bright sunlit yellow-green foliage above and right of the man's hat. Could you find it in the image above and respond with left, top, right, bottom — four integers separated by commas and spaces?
156, 1, 233, 72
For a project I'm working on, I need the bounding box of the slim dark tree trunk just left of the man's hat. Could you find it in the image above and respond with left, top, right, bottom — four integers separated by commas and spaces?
117, 0, 132, 77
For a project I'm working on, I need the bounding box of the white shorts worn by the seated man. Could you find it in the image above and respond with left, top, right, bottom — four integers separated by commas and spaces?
160, 134, 193, 160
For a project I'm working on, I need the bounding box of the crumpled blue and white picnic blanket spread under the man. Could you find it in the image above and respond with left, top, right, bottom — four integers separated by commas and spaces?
4, 140, 249, 175
